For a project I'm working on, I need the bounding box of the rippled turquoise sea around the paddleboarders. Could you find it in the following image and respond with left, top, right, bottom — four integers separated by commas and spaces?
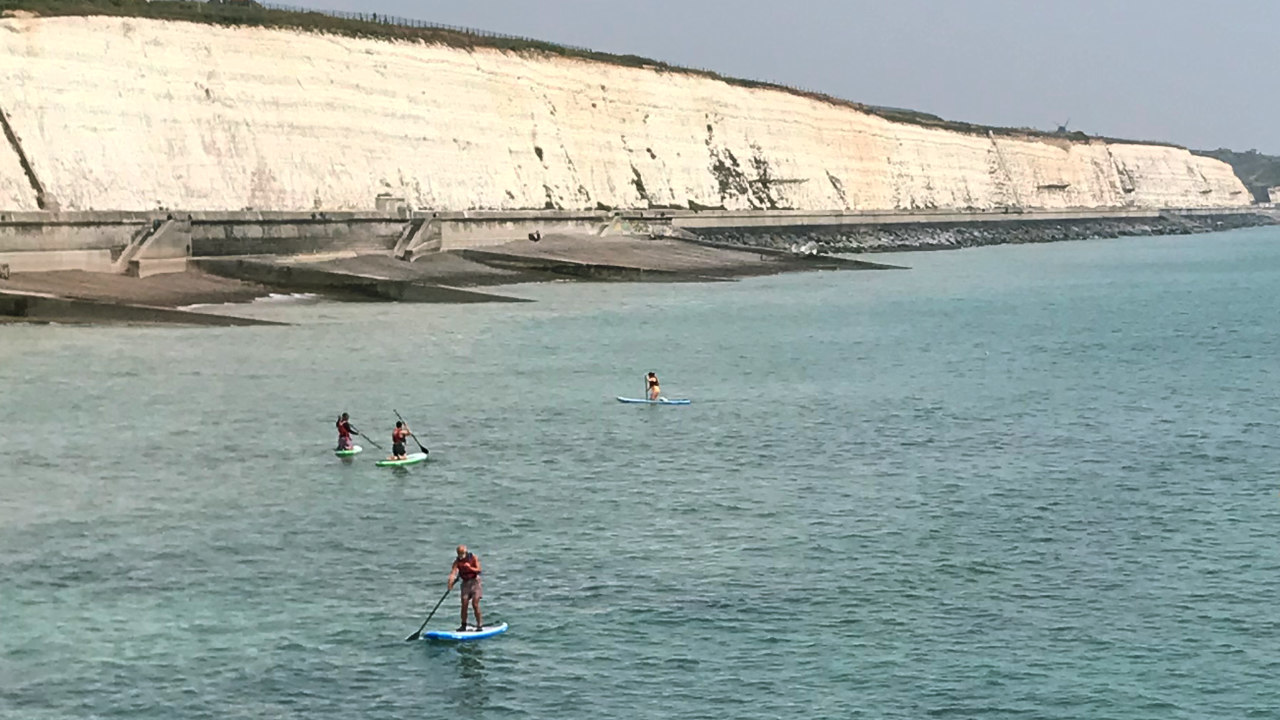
0, 229, 1280, 720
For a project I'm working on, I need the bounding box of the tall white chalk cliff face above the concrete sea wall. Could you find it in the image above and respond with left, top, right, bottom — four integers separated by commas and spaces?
0, 17, 1251, 210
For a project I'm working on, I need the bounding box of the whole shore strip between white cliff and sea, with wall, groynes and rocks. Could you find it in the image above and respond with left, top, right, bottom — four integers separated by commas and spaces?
0, 206, 1277, 324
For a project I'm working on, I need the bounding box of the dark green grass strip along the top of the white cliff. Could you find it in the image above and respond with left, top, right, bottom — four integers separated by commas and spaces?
0, 0, 1176, 147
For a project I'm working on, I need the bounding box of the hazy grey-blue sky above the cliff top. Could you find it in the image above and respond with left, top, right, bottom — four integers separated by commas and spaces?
289, 0, 1280, 154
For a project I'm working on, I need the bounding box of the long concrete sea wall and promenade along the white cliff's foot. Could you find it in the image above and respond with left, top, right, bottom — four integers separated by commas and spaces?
0, 206, 1275, 277
